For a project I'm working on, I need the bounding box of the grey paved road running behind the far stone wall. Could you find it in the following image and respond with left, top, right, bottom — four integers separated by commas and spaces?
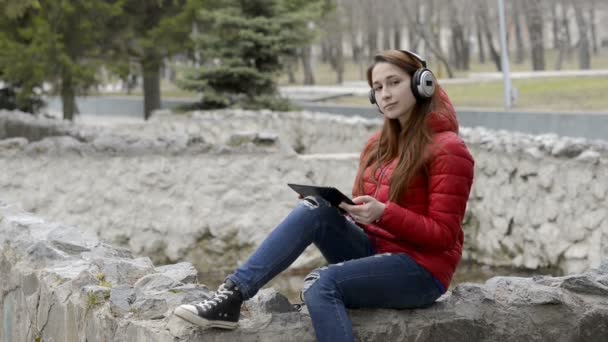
48, 96, 608, 141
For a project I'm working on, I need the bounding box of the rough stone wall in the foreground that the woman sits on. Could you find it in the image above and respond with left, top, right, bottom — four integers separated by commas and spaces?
0, 201, 608, 342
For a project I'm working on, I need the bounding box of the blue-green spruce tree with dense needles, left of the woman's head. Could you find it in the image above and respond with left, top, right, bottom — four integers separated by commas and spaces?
180, 0, 321, 110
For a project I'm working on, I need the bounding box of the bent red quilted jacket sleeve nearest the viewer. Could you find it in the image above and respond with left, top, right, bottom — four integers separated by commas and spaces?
375, 133, 474, 251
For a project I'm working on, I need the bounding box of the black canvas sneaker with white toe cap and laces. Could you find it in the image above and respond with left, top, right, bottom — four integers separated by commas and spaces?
175, 279, 243, 329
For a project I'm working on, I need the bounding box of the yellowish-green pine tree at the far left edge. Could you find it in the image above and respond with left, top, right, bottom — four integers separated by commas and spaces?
0, 0, 121, 120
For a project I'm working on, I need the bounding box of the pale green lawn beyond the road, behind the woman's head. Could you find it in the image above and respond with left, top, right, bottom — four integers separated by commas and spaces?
331, 77, 608, 112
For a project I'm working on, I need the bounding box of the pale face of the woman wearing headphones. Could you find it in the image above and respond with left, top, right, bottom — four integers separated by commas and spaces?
372, 62, 416, 125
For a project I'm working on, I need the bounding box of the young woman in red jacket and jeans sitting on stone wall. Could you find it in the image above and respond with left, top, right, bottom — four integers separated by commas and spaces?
175, 50, 473, 342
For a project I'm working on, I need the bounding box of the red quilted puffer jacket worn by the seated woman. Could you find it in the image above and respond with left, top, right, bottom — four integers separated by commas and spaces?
355, 91, 474, 289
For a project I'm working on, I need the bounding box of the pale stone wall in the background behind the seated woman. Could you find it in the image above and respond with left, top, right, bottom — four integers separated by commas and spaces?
0, 111, 608, 273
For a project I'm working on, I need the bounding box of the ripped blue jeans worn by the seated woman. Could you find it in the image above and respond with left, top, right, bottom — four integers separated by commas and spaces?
228, 197, 441, 342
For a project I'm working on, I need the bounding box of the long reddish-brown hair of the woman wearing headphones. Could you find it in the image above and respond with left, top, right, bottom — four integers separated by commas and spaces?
355, 50, 441, 202
